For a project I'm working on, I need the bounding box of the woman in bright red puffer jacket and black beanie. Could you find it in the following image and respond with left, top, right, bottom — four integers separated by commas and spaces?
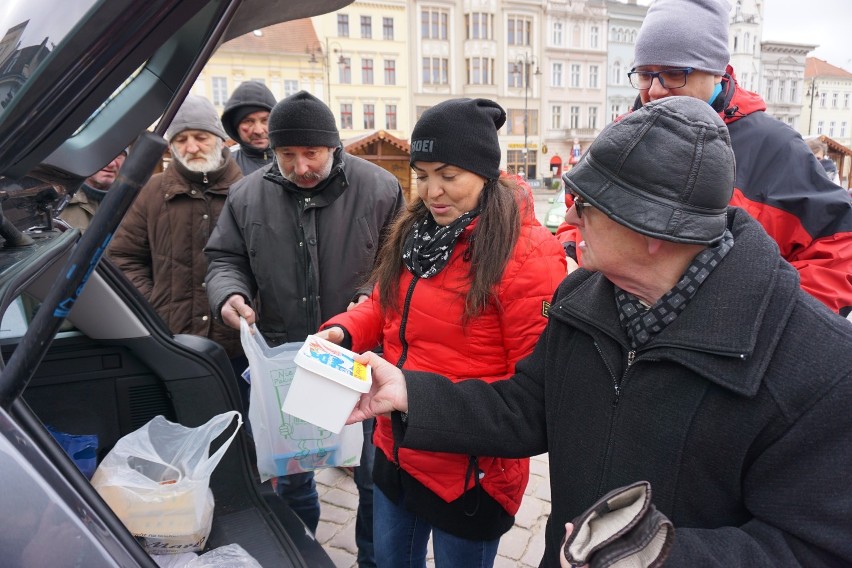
321, 99, 566, 567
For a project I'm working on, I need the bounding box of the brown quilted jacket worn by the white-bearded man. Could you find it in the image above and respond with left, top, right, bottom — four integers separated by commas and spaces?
107, 148, 242, 357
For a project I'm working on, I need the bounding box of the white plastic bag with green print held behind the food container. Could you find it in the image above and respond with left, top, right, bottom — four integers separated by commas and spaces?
240, 318, 364, 481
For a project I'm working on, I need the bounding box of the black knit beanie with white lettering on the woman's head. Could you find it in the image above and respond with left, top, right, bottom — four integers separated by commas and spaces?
410, 99, 506, 179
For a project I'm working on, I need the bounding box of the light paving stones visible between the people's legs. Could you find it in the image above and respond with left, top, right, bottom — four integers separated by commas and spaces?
316, 454, 550, 568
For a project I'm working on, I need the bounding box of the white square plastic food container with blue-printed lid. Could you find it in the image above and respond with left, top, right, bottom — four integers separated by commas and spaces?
282, 335, 373, 434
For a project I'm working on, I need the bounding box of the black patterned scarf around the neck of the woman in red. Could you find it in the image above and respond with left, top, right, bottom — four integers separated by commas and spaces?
402, 207, 479, 278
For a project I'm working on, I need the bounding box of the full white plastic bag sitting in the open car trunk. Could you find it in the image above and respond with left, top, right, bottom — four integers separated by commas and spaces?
92, 411, 242, 554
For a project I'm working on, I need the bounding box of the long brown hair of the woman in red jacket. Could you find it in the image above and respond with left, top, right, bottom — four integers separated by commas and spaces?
370, 177, 533, 320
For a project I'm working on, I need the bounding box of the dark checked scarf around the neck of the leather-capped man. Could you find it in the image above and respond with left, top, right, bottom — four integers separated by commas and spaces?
615, 229, 734, 349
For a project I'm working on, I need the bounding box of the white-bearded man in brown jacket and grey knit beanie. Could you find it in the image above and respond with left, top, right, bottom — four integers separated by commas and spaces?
107, 95, 245, 368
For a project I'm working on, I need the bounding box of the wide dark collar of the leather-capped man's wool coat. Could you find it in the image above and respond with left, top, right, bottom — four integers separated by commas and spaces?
551, 208, 799, 396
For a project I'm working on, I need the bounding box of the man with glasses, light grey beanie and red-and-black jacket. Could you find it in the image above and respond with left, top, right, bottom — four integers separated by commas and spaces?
557, 0, 852, 316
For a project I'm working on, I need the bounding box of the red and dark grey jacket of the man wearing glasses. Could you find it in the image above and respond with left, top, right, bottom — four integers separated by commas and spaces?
557, 66, 852, 316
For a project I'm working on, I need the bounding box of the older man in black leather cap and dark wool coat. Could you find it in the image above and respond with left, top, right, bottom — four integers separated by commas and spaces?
350, 97, 852, 568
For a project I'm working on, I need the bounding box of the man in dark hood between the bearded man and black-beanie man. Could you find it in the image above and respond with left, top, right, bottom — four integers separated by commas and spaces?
222, 81, 275, 175
